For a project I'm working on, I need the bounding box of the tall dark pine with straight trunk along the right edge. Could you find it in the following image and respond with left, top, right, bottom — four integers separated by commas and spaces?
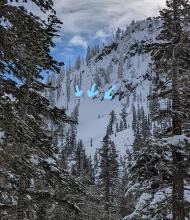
151, 0, 190, 220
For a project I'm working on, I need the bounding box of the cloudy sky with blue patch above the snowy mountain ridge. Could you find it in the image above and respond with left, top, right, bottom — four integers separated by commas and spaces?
53, 0, 165, 66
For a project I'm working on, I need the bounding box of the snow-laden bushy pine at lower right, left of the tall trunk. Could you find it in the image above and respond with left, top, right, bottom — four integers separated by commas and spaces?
125, 138, 172, 220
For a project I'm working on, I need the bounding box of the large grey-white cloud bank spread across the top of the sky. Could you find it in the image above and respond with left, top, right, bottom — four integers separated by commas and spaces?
55, 0, 165, 37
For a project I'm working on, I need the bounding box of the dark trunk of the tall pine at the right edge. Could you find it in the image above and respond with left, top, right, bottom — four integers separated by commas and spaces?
172, 43, 185, 220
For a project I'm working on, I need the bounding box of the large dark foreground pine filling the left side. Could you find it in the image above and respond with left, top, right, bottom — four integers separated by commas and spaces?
0, 0, 80, 220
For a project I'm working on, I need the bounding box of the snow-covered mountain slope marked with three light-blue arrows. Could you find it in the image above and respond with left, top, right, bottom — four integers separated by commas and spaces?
49, 18, 161, 154
